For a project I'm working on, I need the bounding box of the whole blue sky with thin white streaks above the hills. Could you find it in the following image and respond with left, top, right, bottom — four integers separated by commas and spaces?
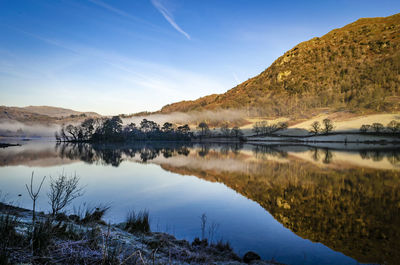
0, 0, 400, 114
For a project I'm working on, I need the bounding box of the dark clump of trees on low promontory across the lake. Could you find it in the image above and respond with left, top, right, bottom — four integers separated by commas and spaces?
55, 116, 193, 142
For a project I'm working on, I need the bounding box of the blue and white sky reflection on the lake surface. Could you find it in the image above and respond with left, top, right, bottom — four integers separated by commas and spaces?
0, 143, 355, 264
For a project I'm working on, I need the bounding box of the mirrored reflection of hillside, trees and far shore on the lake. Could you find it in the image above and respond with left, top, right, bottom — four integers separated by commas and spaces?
0, 142, 400, 264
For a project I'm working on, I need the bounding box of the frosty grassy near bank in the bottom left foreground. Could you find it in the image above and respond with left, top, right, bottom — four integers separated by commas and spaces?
0, 202, 281, 265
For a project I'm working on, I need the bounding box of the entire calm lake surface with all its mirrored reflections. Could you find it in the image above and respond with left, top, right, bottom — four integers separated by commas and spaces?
0, 141, 400, 264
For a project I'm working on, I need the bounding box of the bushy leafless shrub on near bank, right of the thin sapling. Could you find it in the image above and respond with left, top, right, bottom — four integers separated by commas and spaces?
47, 172, 83, 217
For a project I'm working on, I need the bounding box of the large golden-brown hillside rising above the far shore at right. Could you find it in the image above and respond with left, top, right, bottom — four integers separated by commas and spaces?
160, 14, 400, 116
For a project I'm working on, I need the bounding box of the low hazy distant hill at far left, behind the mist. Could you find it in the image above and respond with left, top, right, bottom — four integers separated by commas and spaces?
0, 106, 101, 124
